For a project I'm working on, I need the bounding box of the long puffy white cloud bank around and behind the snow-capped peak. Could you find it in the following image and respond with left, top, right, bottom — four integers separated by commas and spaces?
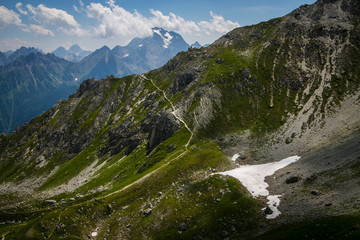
87, 0, 240, 42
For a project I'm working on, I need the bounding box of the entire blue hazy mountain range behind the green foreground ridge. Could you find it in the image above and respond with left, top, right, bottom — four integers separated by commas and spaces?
0, 28, 197, 134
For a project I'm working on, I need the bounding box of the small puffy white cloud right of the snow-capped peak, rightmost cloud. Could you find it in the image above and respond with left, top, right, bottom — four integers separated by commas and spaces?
199, 11, 240, 34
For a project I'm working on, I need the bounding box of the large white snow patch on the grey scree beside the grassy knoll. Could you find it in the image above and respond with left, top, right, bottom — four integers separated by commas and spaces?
215, 154, 300, 219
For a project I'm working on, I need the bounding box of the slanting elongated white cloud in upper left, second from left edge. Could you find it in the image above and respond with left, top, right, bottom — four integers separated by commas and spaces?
26, 4, 79, 27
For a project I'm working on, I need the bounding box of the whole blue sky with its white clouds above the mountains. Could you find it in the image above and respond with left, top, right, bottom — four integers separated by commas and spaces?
0, 0, 315, 52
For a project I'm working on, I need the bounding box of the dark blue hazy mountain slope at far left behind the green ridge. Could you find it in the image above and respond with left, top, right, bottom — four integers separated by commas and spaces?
0, 52, 78, 133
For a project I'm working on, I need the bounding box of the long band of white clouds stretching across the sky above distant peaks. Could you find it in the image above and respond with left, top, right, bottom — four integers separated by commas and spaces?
0, 0, 240, 50
